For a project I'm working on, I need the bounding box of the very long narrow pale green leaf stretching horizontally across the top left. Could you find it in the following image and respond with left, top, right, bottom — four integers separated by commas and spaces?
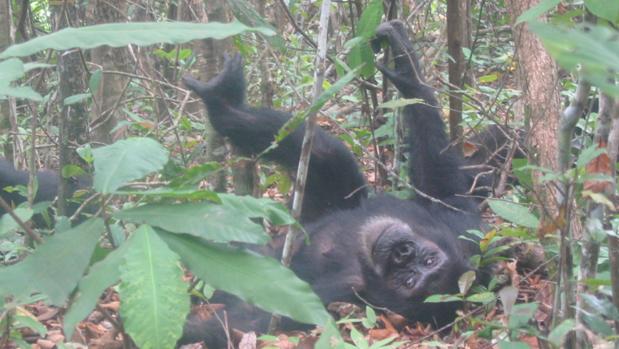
0, 22, 275, 58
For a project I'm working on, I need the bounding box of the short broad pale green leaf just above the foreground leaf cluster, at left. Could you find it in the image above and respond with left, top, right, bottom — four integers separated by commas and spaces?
92, 138, 168, 193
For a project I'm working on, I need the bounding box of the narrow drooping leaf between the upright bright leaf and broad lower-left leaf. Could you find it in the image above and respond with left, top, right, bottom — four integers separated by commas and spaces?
63, 239, 129, 338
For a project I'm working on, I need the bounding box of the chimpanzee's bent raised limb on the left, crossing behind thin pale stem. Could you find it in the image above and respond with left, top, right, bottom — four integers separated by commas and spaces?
185, 55, 367, 221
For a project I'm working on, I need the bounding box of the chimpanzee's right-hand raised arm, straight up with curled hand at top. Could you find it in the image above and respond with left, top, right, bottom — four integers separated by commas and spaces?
373, 21, 469, 204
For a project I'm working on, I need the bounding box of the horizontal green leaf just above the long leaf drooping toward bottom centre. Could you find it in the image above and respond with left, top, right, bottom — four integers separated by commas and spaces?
113, 202, 269, 244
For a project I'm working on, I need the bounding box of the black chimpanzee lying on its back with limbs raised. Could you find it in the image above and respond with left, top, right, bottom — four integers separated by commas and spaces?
181, 21, 481, 348
